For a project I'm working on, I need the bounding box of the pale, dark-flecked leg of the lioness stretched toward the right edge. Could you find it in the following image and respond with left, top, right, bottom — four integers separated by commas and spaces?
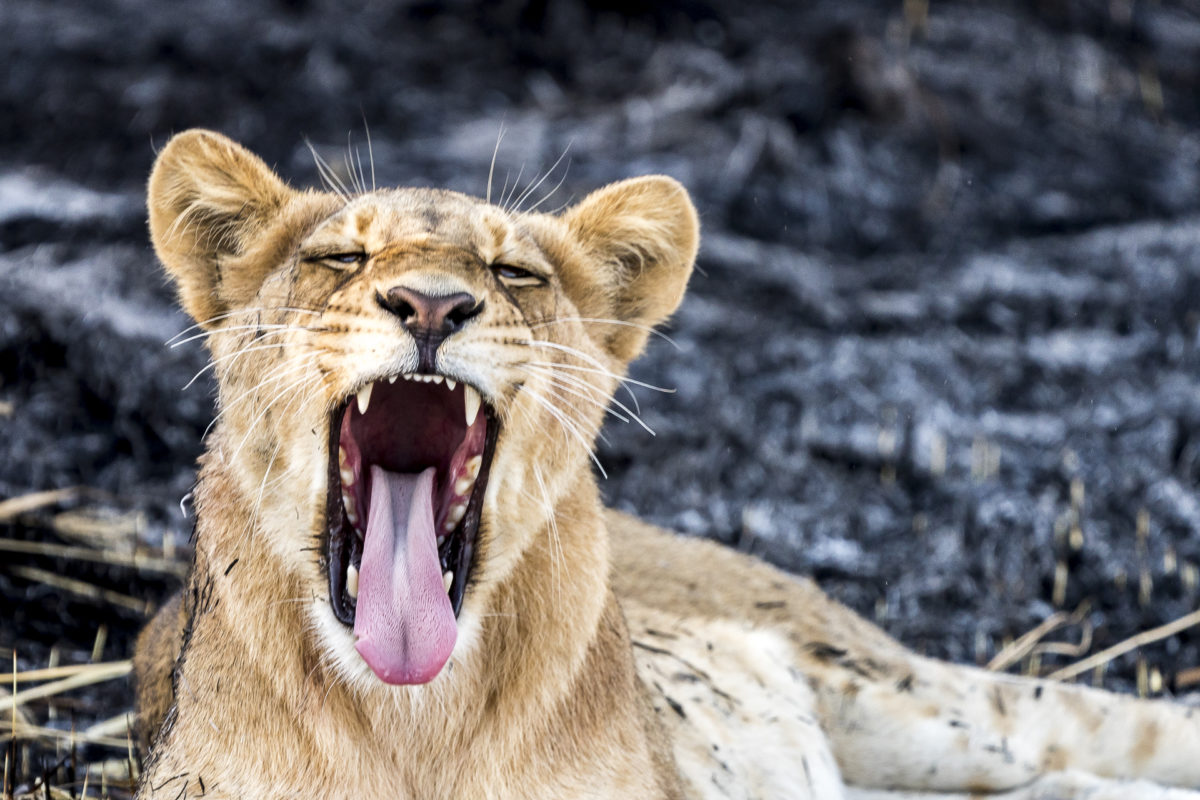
818, 655, 1200, 798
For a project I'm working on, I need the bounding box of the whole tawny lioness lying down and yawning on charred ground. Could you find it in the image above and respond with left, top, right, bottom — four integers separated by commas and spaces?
136, 131, 1200, 800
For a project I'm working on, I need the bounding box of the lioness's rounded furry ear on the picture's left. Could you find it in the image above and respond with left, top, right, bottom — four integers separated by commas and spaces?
146, 130, 296, 327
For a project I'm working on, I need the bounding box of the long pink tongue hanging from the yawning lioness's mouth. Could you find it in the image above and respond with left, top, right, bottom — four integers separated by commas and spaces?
354, 467, 458, 684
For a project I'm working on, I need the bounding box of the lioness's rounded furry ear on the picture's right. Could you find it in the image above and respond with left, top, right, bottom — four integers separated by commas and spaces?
563, 175, 700, 361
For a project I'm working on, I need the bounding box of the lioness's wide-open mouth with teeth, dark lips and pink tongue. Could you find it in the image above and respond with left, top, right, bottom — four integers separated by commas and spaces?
325, 374, 499, 684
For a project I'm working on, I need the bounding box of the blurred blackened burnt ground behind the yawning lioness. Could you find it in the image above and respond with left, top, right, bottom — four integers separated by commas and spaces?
0, 0, 1200, 786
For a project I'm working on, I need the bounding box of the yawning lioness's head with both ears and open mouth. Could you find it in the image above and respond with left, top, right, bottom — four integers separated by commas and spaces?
150, 132, 697, 684
